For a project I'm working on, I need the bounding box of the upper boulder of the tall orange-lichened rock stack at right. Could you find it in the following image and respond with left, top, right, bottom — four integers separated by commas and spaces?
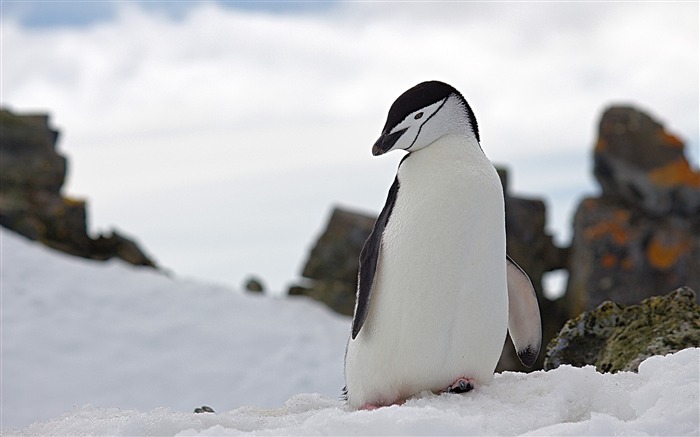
593, 107, 700, 217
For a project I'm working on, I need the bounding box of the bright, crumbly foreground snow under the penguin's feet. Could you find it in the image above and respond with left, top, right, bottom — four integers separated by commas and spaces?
13, 349, 700, 436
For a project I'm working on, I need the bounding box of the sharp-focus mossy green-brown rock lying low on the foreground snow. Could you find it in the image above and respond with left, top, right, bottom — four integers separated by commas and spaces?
544, 287, 700, 372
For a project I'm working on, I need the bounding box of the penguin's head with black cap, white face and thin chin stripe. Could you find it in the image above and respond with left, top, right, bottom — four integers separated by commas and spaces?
372, 81, 479, 156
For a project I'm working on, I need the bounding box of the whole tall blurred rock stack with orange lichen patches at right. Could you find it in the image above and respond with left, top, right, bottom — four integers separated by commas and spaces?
566, 107, 700, 317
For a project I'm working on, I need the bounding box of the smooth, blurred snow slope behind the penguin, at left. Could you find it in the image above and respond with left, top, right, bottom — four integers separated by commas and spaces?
0, 230, 350, 428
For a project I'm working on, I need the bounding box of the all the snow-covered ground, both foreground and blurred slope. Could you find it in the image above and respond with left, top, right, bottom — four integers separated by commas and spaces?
0, 230, 700, 436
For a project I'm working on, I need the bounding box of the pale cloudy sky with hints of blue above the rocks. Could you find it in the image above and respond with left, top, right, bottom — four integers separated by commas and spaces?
0, 0, 700, 291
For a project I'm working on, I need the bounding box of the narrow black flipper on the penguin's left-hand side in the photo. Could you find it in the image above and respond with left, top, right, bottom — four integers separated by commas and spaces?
352, 175, 400, 340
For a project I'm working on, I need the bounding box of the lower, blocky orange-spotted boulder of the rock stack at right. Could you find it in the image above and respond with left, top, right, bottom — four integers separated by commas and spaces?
566, 198, 700, 316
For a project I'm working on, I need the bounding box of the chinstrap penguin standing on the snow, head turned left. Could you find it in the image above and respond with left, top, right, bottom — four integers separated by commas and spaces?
343, 81, 541, 409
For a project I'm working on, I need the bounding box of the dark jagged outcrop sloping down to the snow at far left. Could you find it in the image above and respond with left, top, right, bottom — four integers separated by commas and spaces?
0, 110, 155, 267
